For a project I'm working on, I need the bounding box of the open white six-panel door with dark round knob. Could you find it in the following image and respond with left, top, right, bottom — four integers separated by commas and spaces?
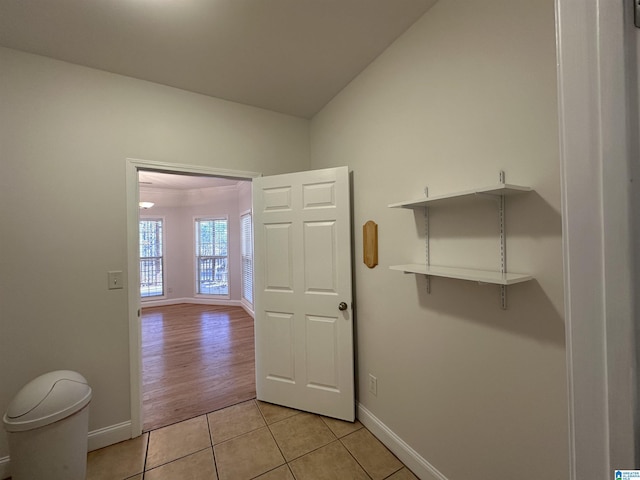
253, 167, 355, 421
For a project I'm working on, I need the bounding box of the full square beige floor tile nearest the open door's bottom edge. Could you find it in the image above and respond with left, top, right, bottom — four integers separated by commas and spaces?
269, 413, 336, 462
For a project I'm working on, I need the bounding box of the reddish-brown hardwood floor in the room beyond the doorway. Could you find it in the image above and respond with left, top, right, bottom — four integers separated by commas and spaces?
142, 304, 256, 431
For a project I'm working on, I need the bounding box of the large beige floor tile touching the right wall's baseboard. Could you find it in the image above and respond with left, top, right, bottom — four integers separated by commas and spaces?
341, 428, 403, 480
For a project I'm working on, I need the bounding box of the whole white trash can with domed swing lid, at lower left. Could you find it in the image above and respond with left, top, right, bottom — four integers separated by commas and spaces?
2, 370, 91, 480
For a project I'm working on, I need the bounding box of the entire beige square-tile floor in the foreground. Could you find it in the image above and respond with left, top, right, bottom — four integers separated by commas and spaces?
87, 400, 417, 480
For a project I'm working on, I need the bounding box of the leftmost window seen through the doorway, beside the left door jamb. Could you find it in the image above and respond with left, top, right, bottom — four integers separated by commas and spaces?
140, 218, 164, 297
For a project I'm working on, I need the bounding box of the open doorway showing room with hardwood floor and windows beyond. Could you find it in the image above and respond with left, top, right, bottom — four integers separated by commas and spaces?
127, 160, 257, 435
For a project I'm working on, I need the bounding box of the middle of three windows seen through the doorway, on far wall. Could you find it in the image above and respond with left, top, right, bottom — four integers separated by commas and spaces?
196, 218, 229, 295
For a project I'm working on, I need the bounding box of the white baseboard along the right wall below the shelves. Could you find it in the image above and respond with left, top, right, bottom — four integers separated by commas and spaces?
358, 403, 447, 480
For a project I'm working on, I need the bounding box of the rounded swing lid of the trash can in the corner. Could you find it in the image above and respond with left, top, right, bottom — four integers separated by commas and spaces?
2, 370, 91, 432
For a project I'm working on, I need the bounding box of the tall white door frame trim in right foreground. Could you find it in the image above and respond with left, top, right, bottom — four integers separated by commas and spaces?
555, 0, 640, 474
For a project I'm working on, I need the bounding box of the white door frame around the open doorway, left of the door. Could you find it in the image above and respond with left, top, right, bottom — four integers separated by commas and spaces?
125, 158, 262, 438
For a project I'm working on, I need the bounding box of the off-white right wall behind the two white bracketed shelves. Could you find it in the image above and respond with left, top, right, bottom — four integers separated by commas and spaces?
311, 0, 568, 480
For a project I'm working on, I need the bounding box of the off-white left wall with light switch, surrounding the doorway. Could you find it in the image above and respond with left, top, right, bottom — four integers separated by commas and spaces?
0, 48, 309, 458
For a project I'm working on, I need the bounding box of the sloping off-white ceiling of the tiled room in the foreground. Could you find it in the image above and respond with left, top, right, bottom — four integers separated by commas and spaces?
0, 0, 436, 118
